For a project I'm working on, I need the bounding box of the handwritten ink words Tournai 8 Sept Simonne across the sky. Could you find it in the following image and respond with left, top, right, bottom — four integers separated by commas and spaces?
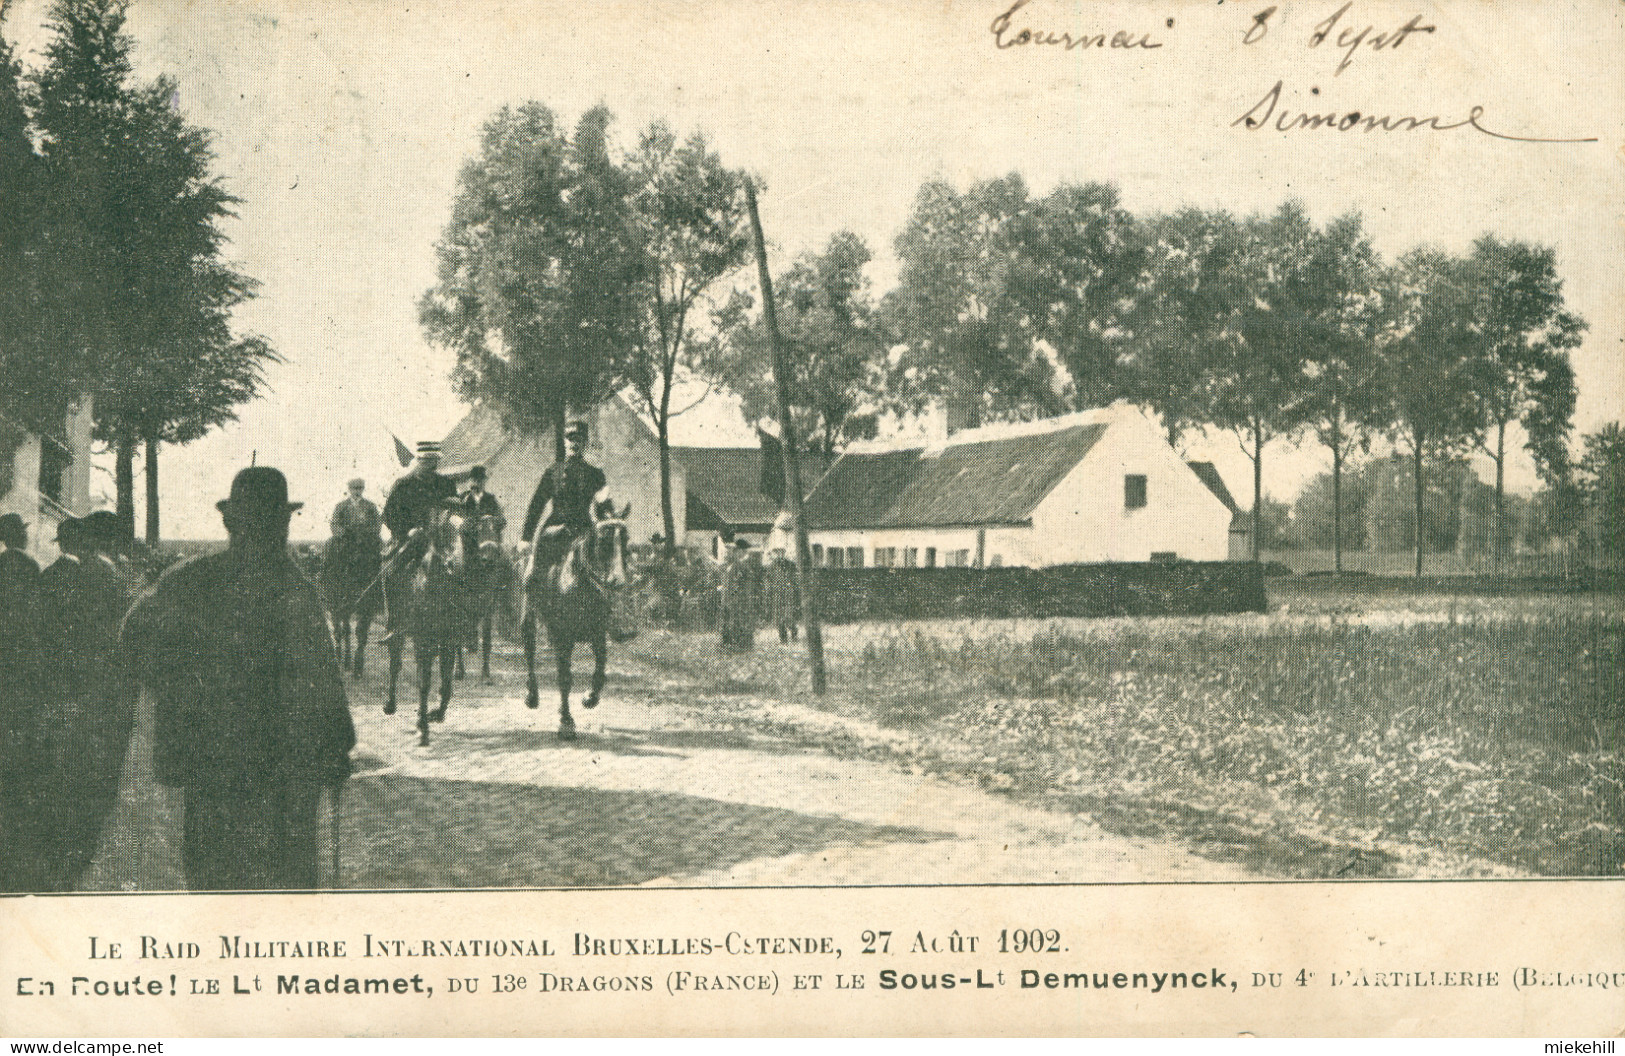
988, 0, 1597, 143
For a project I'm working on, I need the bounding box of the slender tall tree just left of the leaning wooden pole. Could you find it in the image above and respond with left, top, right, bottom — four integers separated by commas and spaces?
621, 122, 751, 549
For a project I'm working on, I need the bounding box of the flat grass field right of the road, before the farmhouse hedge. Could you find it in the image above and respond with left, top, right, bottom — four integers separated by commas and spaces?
624, 580, 1625, 876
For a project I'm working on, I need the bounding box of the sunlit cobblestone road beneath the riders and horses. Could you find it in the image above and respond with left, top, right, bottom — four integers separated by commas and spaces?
86, 633, 1250, 890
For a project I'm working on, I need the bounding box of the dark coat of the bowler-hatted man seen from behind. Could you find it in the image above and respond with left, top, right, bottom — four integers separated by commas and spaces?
124, 547, 356, 791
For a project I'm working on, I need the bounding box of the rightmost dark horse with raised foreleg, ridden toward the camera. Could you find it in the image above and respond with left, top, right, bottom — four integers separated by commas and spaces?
520, 504, 632, 741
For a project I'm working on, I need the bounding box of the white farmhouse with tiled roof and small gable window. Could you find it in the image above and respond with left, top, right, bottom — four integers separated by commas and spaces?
806, 405, 1235, 567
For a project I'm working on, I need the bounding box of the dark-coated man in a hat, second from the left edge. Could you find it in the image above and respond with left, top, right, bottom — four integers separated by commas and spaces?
37, 513, 135, 890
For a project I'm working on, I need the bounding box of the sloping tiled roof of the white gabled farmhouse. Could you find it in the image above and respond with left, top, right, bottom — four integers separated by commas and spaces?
808, 421, 1107, 528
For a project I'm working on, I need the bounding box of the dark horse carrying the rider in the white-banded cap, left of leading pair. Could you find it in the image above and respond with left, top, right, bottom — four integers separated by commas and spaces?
384, 505, 473, 744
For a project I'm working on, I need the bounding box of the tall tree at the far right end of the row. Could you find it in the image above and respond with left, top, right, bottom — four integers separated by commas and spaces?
1466, 234, 1586, 564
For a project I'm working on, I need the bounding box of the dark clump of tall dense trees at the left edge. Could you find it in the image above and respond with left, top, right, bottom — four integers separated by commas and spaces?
0, 0, 276, 541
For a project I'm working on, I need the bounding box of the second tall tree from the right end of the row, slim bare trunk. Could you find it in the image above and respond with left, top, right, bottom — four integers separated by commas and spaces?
1378, 249, 1480, 577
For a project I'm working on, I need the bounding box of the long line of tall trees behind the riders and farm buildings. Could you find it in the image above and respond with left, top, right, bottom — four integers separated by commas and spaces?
423, 102, 1584, 569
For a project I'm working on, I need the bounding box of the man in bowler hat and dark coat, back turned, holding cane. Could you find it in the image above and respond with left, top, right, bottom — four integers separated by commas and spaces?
124, 466, 356, 890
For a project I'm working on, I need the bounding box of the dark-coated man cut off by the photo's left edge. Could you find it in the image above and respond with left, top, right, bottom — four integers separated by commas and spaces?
0, 513, 47, 892
